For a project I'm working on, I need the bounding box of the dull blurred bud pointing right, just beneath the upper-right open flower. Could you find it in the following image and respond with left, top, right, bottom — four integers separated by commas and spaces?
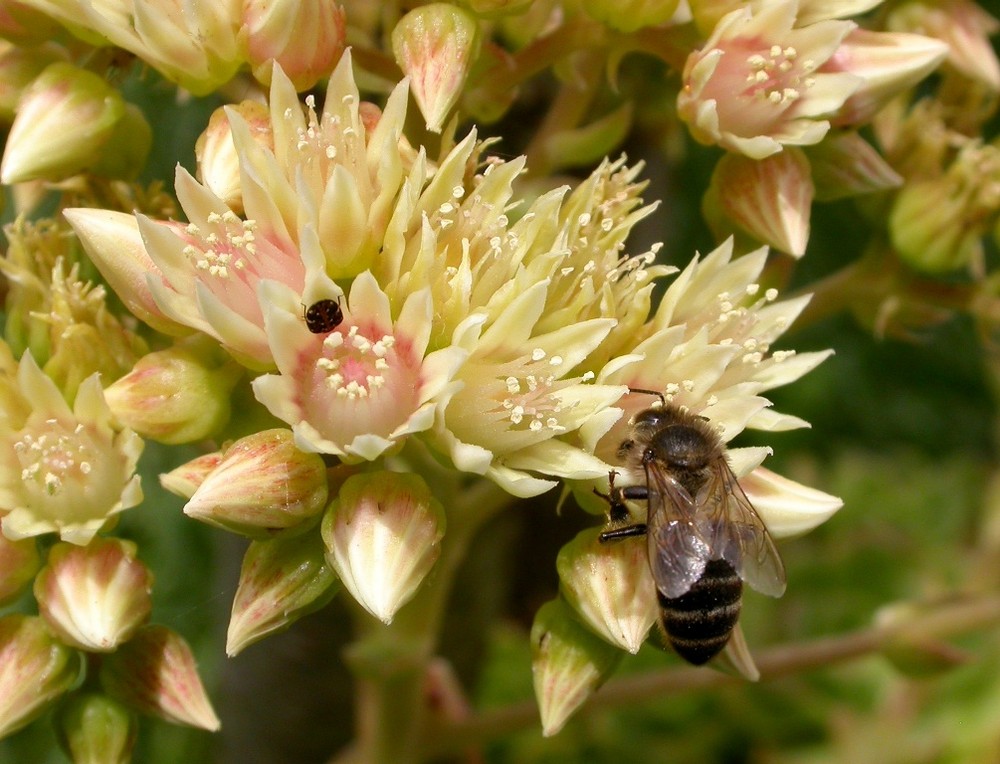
808, 131, 903, 202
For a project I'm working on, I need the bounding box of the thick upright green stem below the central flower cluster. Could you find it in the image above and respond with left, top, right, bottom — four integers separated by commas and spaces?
342, 479, 512, 764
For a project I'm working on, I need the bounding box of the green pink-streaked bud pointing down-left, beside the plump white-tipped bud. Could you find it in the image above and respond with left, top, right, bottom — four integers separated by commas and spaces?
226, 533, 338, 656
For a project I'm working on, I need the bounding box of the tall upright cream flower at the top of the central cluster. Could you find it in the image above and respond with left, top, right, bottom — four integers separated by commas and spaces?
229, 53, 409, 283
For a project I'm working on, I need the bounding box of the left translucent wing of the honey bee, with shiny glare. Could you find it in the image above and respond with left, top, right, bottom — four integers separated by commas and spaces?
646, 463, 712, 599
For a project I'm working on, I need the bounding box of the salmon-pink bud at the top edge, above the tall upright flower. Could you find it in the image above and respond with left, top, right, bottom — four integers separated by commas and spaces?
243, 0, 347, 92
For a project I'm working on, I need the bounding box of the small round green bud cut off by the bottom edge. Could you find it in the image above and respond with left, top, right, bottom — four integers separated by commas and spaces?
55, 693, 139, 764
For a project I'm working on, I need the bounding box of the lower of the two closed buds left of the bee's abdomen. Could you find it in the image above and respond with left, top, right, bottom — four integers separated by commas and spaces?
531, 599, 624, 737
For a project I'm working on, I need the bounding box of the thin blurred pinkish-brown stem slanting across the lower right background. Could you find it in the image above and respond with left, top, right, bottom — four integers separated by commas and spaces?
424, 595, 1000, 756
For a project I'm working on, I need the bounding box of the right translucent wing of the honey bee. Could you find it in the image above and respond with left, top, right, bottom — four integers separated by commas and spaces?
694, 459, 785, 597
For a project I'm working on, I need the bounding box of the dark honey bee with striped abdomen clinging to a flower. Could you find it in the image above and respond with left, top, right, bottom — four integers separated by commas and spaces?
600, 402, 785, 666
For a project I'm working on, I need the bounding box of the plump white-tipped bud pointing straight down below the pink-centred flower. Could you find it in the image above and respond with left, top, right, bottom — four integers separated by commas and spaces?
322, 472, 445, 623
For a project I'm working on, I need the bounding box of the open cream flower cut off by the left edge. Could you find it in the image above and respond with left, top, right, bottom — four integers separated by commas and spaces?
0, 354, 142, 545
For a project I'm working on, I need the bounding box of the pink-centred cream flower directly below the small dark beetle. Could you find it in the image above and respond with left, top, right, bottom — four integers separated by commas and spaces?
253, 273, 466, 461
